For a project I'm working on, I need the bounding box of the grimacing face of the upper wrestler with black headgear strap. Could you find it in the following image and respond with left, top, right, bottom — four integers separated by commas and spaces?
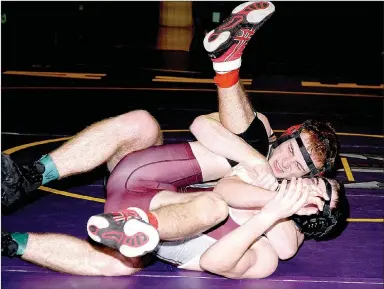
268, 133, 321, 179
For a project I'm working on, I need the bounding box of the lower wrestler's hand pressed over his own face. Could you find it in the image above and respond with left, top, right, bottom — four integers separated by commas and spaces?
262, 178, 309, 219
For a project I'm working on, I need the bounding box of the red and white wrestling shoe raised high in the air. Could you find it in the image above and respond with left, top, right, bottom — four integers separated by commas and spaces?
204, 2, 275, 72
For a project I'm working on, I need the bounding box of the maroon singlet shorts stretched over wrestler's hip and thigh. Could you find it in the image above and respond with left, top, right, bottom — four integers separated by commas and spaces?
105, 143, 207, 212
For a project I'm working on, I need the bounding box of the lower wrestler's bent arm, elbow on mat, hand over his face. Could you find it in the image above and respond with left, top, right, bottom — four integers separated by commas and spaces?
200, 178, 309, 278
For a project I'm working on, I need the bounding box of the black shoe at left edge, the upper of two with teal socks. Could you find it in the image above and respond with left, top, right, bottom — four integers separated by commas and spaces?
1, 153, 44, 207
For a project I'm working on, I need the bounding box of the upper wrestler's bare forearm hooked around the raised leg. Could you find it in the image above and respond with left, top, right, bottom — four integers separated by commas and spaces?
190, 114, 268, 166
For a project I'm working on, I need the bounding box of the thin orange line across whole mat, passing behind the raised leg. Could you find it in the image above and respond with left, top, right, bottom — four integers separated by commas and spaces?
1, 86, 383, 98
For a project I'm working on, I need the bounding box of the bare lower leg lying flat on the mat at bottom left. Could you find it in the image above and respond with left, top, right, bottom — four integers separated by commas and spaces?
22, 233, 141, 276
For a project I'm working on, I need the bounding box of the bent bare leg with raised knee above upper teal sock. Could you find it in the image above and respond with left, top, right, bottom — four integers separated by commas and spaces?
49, 110, 161, 178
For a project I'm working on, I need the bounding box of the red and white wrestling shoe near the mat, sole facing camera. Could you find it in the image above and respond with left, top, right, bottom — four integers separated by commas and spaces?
87, 207, 160, 258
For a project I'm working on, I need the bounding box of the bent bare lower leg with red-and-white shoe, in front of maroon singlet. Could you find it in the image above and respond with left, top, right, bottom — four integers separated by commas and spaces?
87, 191, 228, 257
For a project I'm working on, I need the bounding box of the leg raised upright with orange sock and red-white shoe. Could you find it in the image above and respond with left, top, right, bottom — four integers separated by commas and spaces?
203, 2, 275, 134
